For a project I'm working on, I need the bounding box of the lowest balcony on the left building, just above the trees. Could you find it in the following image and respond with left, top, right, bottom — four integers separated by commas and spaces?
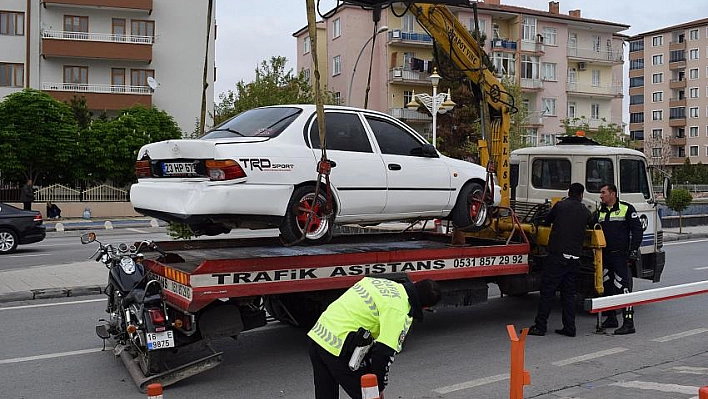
42, 83, 152, 111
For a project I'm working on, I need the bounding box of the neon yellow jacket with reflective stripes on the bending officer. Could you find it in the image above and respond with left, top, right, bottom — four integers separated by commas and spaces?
307, 277, 413, 356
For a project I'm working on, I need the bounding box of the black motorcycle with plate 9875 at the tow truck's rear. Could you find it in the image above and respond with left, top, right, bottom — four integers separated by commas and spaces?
81, 232, 175, 376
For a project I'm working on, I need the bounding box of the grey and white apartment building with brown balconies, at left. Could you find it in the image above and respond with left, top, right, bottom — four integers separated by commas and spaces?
0, 0, 216, 132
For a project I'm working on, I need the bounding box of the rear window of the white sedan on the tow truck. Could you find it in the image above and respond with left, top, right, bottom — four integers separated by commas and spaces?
202, 107, 302, 140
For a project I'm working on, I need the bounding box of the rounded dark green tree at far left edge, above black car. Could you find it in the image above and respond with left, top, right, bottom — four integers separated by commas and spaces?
0, 89, 78, 185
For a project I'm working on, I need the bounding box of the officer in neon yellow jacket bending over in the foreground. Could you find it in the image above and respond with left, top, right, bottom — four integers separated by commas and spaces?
307, 277, 441, 399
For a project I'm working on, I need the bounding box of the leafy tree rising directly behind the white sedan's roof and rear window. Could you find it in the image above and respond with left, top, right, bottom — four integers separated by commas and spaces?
214, 57, 334, 126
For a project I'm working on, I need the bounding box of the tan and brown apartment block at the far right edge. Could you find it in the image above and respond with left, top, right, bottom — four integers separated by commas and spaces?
629, 18, 708, 167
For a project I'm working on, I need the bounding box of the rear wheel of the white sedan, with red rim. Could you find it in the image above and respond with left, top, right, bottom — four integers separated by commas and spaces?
280, 186, 332, 245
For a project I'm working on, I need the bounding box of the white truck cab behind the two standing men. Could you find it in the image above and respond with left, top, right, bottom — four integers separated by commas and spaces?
511, 136, 665, 282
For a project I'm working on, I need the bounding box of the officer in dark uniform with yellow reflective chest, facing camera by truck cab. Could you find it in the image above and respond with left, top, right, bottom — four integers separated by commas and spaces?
597, 184, 643, 335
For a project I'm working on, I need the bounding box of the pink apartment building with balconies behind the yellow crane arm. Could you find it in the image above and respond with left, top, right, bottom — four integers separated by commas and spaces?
293, 0, 629, 145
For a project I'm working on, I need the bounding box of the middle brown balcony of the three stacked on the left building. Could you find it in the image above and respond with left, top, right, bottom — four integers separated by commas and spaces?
42, 30, 153, 63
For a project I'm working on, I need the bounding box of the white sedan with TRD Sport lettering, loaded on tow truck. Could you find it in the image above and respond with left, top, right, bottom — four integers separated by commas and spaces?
130, 105, 500, 244
